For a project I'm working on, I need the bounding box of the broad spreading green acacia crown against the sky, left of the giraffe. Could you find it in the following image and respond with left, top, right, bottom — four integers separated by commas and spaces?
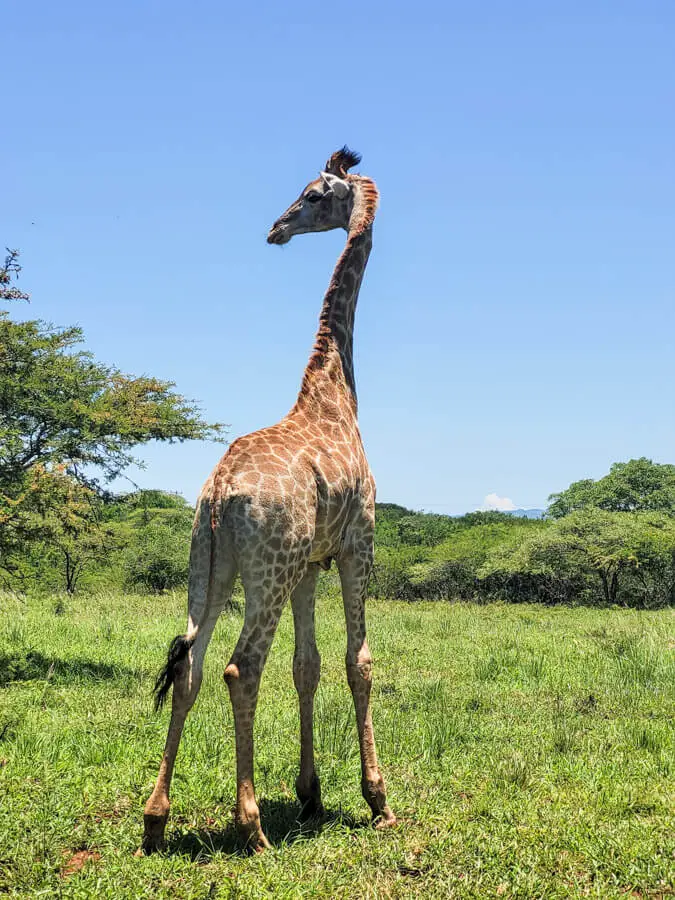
0, 312, 221, 492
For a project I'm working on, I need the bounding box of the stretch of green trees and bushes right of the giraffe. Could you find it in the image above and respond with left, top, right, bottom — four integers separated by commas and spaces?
372, 459, 675, 608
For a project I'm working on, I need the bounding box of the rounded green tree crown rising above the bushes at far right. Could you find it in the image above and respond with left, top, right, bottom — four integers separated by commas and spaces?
548, 456, 675, 519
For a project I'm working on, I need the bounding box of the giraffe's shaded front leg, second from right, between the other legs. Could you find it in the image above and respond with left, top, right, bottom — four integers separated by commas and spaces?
291, 564, 323, 819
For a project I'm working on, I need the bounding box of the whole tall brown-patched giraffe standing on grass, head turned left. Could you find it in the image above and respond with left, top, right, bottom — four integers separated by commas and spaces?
141, 146, 396, 853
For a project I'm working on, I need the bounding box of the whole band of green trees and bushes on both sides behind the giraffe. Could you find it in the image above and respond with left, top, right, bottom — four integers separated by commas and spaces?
0, 251, 675, 608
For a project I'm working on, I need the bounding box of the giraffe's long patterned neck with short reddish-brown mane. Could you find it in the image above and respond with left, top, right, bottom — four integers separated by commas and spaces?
296, 179, 377, 416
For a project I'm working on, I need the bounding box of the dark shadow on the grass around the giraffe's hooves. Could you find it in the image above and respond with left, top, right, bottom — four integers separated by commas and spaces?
166, 799, 368, 862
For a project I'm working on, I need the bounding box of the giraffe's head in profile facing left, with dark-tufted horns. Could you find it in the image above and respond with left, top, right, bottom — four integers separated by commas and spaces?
267, 146, 374, 244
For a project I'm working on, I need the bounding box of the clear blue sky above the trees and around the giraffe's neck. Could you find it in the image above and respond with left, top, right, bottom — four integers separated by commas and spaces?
5, 0, 675, 512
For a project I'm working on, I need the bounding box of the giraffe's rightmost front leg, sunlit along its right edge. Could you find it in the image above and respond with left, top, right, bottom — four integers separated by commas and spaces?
338, 552, 396, 828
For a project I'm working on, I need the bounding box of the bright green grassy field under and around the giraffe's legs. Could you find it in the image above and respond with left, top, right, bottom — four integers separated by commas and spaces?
0, 592, 675, 898
